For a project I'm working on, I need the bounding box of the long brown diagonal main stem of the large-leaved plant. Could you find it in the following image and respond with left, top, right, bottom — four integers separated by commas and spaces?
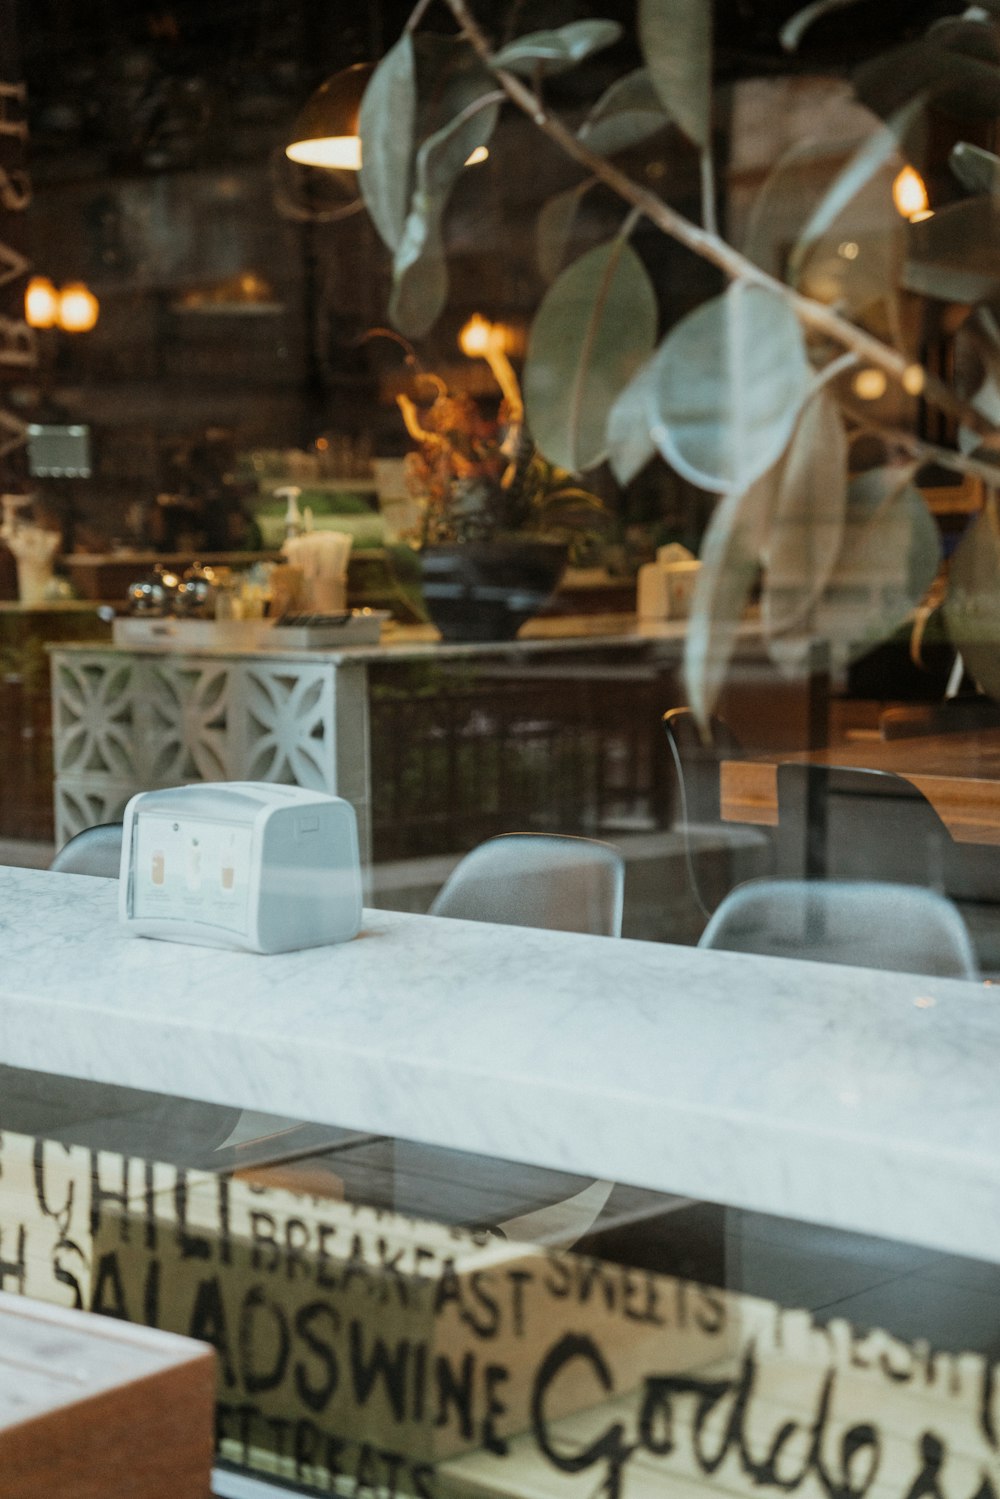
444, 0, 991, 432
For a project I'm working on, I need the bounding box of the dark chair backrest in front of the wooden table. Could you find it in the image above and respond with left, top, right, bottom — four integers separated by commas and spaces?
777, 763, 952, 890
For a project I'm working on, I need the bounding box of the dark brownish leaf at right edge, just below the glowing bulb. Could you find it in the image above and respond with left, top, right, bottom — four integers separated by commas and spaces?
904, 196, 1000, 301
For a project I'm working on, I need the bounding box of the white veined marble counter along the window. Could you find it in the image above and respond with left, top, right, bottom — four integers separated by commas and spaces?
0, 869, 1000, 1261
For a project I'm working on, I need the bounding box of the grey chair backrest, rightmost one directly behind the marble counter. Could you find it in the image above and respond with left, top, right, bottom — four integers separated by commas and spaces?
699, 880, 979, 979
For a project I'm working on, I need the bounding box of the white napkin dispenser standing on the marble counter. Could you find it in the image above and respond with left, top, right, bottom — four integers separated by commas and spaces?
118, 781, 361, 952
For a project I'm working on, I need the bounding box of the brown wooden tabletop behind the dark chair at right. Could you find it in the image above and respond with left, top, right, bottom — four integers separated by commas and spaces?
720, 729, 1000, 845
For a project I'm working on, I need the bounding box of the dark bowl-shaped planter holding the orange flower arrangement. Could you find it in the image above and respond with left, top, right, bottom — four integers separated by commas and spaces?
420, 541, 567, 640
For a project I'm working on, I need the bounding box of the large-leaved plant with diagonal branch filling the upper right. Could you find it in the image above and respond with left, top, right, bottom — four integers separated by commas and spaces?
353, 0, 1000, 720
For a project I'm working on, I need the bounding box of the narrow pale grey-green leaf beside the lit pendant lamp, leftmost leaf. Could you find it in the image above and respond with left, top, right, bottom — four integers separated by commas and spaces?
358, 31, 417, 250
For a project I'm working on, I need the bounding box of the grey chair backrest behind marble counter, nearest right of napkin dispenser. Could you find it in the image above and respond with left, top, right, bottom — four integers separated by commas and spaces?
430, 833, 625, 937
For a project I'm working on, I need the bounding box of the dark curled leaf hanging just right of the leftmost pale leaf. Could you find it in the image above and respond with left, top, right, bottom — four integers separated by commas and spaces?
388, 90, 499, 339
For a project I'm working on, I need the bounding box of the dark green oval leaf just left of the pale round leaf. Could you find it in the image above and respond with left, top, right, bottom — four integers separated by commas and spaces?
525, 237, 657, 471
